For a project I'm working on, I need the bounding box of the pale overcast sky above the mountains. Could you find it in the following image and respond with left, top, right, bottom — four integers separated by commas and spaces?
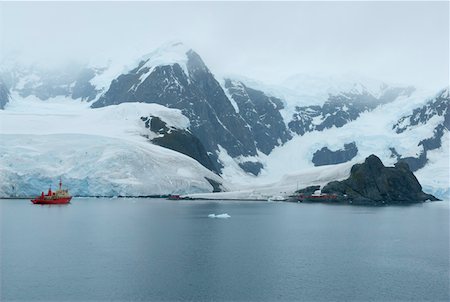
0, 2, 449, 88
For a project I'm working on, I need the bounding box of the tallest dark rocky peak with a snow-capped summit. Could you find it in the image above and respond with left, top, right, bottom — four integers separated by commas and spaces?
92, 43, 285, 174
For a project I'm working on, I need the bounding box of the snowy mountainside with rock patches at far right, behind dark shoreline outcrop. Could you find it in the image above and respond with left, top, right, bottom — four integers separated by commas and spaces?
251, 85, 450, 198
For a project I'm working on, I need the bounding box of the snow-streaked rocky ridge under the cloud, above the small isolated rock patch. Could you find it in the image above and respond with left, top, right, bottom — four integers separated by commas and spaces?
288, 87, 414, 135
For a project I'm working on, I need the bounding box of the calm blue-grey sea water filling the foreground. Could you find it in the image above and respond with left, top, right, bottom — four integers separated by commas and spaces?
0, 199, 450, 301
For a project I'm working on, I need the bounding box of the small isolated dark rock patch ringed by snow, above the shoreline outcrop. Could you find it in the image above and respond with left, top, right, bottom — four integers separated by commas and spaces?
312, 142, 358, 166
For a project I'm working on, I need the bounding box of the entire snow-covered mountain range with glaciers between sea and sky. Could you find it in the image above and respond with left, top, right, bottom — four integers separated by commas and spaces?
0, 43, 449, 197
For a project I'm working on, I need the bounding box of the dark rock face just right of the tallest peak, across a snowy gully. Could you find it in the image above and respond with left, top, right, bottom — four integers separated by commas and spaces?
225, 79, 292, 155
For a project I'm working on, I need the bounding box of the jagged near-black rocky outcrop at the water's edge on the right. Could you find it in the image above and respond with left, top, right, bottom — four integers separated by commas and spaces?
322, 155, 437, 205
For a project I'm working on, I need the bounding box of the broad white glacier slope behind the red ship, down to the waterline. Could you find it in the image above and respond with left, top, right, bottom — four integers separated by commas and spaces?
0, 97, 223, 196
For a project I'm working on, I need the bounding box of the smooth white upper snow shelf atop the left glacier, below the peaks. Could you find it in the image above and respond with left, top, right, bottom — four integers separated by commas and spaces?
0, 96, 189, 141
